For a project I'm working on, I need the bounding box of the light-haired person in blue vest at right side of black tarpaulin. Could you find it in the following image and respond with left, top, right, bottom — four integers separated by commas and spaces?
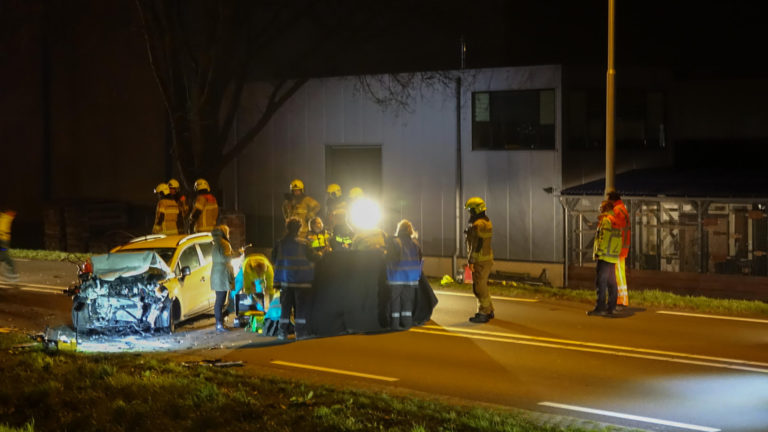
386, 219, 423, 330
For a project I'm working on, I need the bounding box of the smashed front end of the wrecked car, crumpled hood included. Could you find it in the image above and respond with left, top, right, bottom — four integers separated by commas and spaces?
72, 252, 174, 334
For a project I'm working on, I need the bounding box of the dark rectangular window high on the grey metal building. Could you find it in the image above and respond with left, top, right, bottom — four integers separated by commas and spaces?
472, 89, 555, 150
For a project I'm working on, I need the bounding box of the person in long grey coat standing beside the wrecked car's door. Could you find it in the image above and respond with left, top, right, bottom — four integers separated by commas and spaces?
211, 225, 235, 333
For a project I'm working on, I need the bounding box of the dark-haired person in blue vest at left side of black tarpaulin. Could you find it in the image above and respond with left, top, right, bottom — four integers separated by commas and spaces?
272, 217, 319, 340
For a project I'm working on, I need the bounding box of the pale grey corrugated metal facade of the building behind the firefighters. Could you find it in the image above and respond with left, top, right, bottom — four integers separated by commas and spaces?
221, 66, 563, 262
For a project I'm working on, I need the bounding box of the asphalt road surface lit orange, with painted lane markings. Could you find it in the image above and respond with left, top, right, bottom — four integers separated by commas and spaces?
0, 258, 768, 432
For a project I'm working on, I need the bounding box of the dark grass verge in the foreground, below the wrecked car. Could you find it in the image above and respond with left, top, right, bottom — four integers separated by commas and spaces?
0, 334, 628, 432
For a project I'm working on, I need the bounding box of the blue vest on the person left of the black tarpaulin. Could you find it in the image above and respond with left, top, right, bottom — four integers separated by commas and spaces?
272, 237, 315, 288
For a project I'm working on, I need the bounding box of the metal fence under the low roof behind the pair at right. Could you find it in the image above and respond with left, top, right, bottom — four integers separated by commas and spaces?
562, 196, 768, 276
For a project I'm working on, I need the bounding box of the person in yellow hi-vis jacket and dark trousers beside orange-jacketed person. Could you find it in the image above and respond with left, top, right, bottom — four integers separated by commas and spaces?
587, 201, 621, 316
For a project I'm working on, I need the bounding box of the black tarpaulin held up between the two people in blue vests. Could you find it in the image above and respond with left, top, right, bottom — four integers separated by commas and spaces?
304, 251, 437, 339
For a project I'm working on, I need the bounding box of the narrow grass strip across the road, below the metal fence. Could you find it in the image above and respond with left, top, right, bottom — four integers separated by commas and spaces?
430, 279, 768, 318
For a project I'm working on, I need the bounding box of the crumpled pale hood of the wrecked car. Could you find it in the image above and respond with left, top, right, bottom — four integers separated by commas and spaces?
91, 251, 172, 281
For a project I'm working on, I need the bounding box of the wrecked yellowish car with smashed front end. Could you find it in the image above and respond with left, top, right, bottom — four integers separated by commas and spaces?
72, 233, 215, 334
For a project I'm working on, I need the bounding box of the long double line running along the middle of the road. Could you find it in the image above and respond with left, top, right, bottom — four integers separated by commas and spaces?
410, 326, 768, 374
